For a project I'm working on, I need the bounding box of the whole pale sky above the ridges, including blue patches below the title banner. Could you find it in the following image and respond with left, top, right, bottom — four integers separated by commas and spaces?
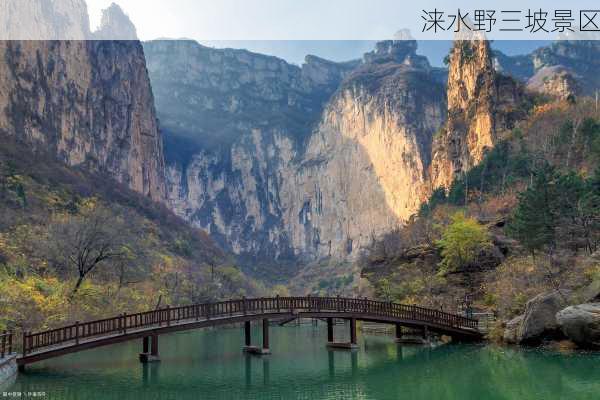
86, 0, 600, 66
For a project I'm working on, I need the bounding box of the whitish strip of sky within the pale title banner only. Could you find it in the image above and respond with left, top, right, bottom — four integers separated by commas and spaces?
87, 0, 600, 40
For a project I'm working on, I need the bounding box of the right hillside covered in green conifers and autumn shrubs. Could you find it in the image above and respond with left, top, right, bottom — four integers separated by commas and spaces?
362, 98, 600, 318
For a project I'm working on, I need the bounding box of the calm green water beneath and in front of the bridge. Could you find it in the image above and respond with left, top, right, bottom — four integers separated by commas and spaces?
7, 325, 600, 400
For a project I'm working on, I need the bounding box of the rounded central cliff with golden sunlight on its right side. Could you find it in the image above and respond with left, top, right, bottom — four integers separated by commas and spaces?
282, 62, 446, 259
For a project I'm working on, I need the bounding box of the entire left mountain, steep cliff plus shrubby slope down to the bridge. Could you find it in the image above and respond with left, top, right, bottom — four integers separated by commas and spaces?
0, 0, 267, 331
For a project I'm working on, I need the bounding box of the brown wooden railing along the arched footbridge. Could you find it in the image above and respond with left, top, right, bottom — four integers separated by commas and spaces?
22, 296, 477, 355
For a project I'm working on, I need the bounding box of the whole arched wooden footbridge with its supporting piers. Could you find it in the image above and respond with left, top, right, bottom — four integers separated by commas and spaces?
17, 297, 482, 368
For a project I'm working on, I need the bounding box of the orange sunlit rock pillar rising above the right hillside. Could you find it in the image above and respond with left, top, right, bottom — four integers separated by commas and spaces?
430, 40, 522, 188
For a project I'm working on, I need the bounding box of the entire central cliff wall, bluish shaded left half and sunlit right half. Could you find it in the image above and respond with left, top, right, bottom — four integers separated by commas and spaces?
145, 37, 446, 262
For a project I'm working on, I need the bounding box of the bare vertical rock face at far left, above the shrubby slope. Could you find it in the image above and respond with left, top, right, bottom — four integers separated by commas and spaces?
0, 1, 165, 201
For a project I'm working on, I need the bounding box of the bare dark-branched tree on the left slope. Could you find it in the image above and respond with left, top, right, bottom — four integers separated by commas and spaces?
48, 205, 132, 295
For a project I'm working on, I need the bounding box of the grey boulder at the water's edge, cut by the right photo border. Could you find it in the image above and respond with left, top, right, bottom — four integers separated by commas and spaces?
556, 303, 600, 348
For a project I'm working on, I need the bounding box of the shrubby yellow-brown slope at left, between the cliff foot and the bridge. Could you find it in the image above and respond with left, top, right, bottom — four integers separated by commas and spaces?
0, 140, 264, 330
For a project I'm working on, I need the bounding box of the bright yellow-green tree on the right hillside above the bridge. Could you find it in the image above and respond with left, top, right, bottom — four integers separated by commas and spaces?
437, 212, 491, 272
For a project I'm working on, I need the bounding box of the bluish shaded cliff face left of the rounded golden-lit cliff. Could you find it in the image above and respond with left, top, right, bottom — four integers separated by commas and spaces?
145, 41, 355, 260
